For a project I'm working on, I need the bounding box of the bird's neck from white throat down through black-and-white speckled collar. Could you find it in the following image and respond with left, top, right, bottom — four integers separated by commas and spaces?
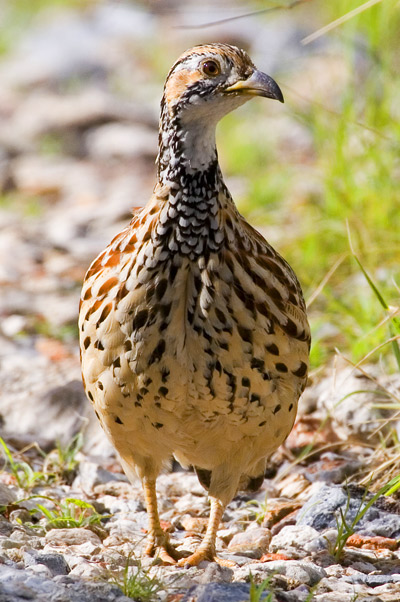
153, 103, 230, 260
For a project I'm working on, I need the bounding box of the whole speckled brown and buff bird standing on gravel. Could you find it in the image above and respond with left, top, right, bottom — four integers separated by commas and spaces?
79, 43, 310, 566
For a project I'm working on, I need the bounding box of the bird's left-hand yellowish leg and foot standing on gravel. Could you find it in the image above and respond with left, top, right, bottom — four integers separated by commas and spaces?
142, 477, 180, 564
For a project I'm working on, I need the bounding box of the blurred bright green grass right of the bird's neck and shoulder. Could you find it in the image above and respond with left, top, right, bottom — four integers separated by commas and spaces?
220, 0, 400, 370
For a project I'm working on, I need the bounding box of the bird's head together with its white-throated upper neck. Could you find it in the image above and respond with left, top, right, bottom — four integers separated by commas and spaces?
157, 44, 283, 181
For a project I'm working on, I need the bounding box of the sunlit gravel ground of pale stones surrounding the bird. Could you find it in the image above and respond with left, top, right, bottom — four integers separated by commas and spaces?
0, 2, 400, 602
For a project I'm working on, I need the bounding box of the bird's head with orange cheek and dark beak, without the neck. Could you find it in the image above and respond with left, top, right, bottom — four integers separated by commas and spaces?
164, 44, 283, 124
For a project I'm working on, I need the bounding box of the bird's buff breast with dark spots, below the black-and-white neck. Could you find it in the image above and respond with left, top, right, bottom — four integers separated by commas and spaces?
81, 204, 307, 438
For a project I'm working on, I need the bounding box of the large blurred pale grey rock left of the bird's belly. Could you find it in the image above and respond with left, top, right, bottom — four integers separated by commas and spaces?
0, 352, 114, 456
